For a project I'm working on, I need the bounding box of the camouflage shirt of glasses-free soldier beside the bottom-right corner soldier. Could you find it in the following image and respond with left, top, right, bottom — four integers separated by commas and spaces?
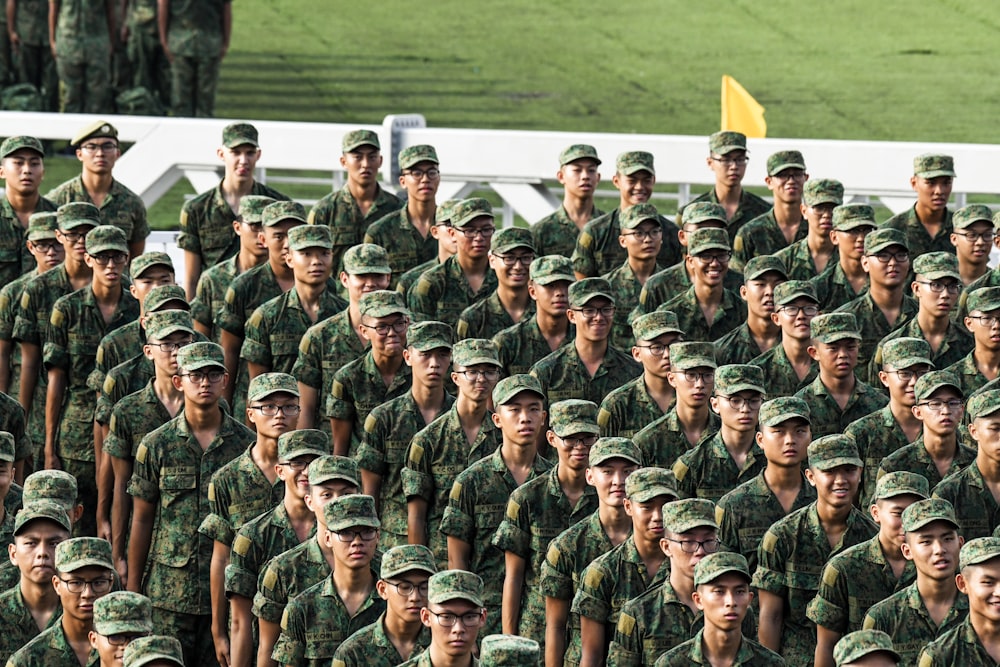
861, 583, 969, 665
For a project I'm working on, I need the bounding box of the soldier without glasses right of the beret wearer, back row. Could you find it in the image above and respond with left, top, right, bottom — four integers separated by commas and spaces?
178, 122, 288, 299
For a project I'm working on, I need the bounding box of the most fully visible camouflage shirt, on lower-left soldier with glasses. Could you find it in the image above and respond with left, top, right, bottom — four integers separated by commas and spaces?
128, 408, 256, 614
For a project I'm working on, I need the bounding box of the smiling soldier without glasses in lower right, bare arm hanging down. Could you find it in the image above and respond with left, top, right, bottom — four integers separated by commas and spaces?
752, 435, 878, 665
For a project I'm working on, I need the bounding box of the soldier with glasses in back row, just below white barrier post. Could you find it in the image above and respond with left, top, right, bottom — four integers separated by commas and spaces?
365, 144, 441, 289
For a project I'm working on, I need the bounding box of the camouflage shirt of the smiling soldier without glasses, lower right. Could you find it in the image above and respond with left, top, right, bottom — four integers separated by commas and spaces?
752, 502, 878, 665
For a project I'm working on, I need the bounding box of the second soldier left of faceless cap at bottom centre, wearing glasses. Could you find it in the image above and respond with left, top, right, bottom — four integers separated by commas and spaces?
333, 544, 437, 667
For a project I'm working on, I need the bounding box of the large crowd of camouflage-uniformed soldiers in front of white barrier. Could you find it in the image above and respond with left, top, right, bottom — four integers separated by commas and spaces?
0, 121, 1000, 667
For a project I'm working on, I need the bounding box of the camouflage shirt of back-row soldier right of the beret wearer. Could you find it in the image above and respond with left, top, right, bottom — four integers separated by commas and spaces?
177, 181, 288, 270
